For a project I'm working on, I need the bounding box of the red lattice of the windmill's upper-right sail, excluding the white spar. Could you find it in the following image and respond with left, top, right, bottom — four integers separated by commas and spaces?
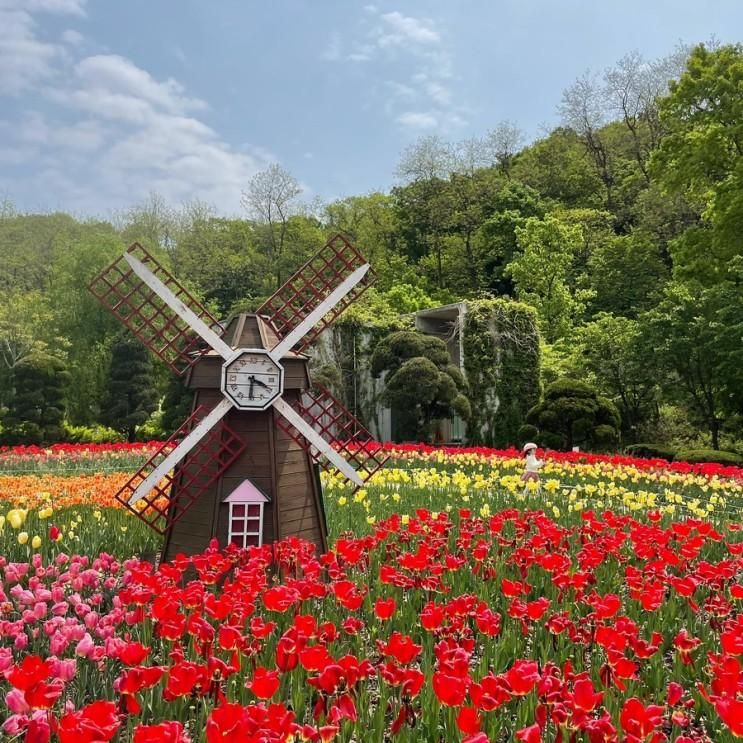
258, 235, 374, 351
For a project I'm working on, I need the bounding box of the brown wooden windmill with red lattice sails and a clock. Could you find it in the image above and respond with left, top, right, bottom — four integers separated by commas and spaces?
90, 235, 388, 560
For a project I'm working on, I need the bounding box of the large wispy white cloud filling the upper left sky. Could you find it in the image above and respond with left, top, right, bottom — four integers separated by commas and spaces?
0, 0, 274, 214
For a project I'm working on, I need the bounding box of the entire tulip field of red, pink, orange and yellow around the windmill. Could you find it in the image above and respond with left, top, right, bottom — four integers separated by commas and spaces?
0, 444, 743, 743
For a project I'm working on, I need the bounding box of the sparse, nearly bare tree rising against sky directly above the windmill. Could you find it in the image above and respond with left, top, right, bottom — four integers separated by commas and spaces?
242, 163, 302, 289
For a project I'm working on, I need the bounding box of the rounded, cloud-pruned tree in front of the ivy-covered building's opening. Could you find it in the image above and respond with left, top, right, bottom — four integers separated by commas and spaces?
371, 330, 470, 441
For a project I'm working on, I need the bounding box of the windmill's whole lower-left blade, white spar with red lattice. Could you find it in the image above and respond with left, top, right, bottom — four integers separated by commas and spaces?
115, 400, 246, 534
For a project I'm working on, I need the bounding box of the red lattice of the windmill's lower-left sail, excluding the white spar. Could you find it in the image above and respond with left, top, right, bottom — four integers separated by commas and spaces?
115, 407, 245, 534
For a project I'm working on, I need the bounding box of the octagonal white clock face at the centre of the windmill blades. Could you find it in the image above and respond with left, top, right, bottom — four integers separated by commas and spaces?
222, 348, 284, 410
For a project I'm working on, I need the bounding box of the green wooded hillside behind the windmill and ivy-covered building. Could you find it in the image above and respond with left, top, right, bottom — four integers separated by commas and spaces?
0, 44, 743, 454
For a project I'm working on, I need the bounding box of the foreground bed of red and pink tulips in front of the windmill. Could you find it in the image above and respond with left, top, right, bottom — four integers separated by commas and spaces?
0, 509, 743, 743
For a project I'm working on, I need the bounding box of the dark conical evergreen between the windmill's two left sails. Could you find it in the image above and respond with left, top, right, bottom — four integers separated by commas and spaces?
101, 336, 158, 441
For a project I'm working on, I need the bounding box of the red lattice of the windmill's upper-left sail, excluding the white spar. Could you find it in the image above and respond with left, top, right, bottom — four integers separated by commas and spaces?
90, 243, 223, 375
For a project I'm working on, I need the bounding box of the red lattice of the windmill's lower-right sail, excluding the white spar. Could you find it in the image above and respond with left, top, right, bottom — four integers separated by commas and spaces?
276, 385, 390, 482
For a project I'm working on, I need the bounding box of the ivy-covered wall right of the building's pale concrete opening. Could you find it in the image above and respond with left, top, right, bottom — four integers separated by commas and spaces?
463, 299, 540, 447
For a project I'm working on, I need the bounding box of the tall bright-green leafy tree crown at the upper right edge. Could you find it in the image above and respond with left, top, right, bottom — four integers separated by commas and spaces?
651, 44, 743, 285
